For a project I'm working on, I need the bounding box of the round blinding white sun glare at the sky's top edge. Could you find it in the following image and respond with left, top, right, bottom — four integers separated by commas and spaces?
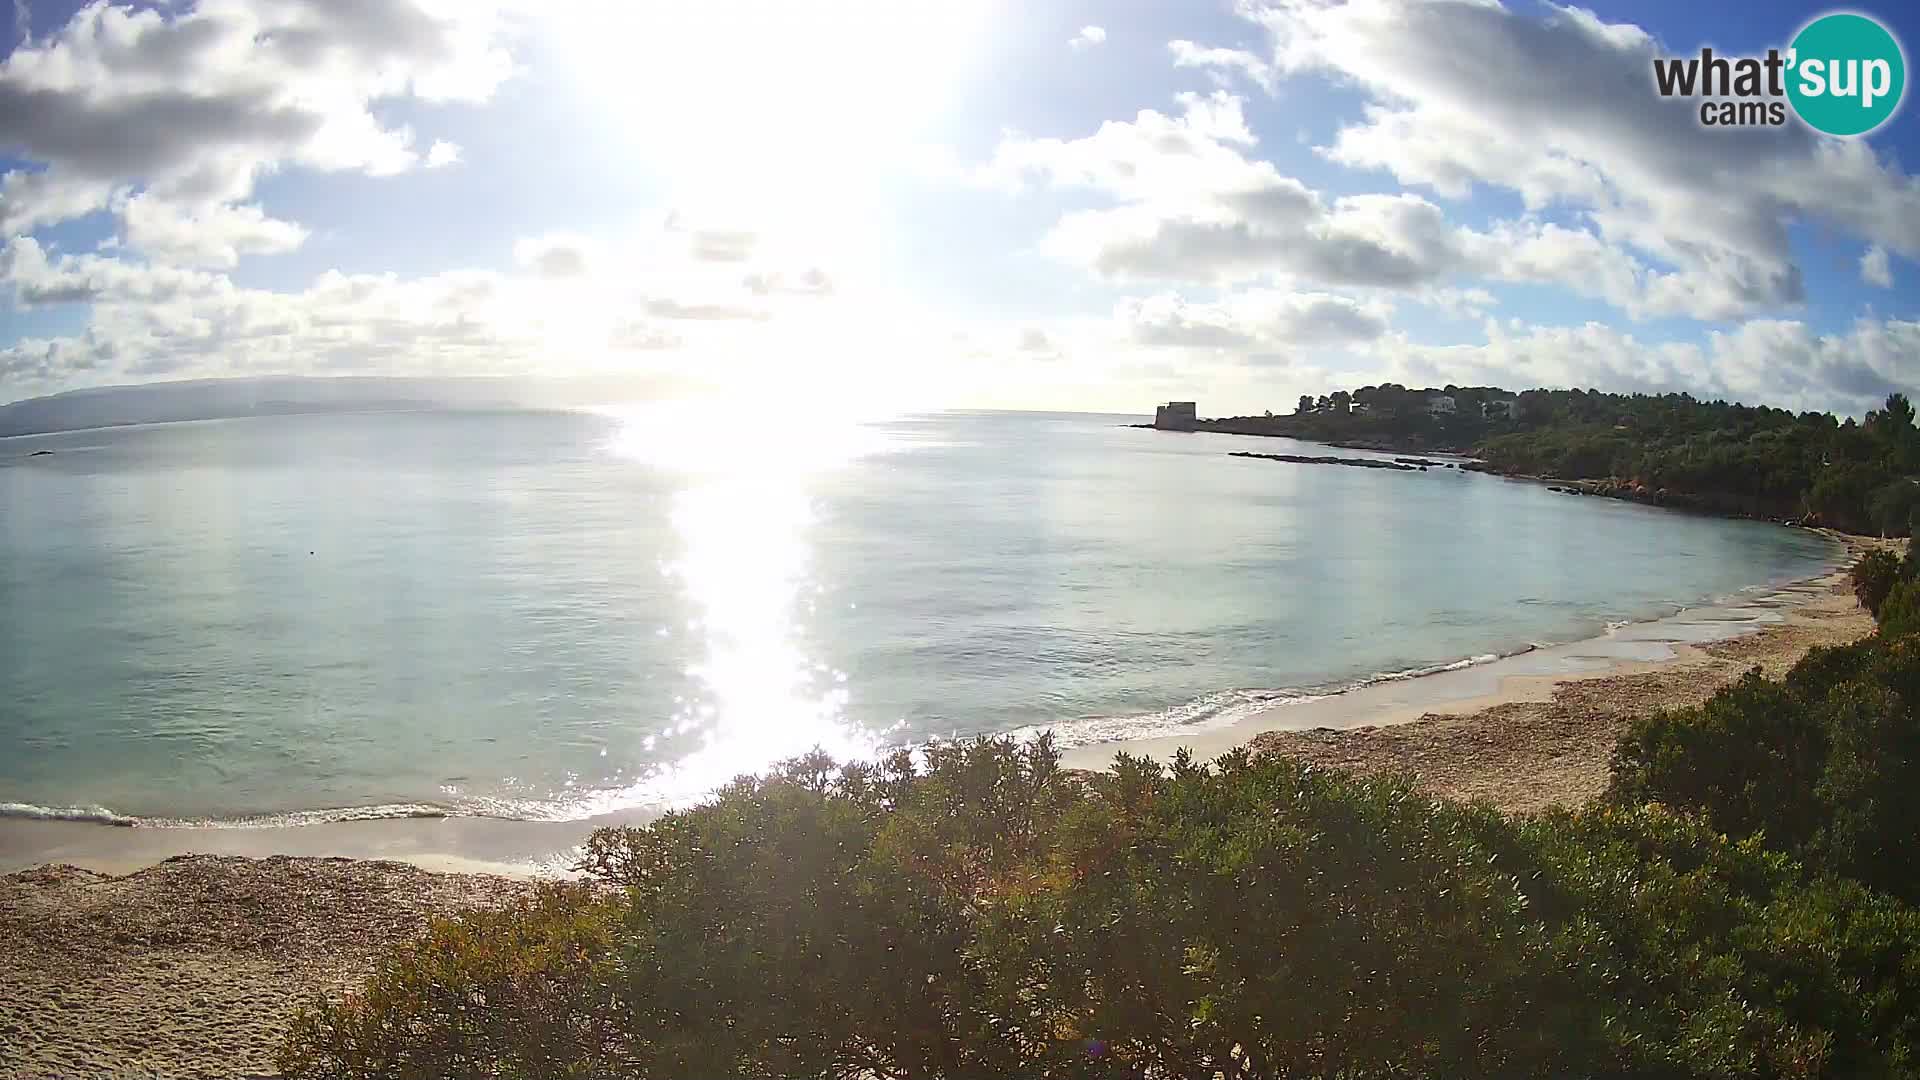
551, 0, 993, 219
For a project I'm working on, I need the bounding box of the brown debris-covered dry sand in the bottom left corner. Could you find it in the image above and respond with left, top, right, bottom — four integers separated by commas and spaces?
0, 855, 528, 1080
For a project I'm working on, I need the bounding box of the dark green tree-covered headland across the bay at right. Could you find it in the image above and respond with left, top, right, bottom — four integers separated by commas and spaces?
1198, 384, 1920, 536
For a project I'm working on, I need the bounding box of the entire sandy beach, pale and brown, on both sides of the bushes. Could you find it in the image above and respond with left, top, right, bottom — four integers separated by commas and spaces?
0, 538, 1882, 1078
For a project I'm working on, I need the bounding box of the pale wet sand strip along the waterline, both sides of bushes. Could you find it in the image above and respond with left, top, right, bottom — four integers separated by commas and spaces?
0, 530, 1858, 878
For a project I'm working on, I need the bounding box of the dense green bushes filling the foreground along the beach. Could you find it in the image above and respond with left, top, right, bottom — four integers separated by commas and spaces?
280, 544, 1920, 1080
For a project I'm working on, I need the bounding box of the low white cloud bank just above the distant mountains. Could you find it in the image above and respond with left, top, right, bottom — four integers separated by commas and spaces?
0, 208, 871, 400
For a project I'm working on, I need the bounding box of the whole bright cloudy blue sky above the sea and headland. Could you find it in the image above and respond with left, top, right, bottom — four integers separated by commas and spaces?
0, 0, 1920, 415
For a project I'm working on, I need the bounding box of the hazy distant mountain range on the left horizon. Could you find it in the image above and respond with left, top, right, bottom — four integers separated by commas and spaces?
0, 377, 691, 438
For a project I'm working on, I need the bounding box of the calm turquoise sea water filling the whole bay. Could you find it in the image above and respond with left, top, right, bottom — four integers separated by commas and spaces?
0, 409, 1830, 821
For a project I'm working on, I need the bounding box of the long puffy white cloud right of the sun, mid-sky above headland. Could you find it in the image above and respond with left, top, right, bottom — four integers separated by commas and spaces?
977, 71, 1881, 319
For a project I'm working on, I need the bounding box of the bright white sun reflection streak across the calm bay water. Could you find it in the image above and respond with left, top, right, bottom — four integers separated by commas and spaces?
576, 405, 887, 813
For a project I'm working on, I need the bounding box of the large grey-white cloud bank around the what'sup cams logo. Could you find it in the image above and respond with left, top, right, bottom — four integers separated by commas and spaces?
1240, 0, 1920, 319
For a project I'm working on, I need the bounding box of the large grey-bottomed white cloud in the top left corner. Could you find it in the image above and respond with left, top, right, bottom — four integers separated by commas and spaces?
0, 0, 513, 263
